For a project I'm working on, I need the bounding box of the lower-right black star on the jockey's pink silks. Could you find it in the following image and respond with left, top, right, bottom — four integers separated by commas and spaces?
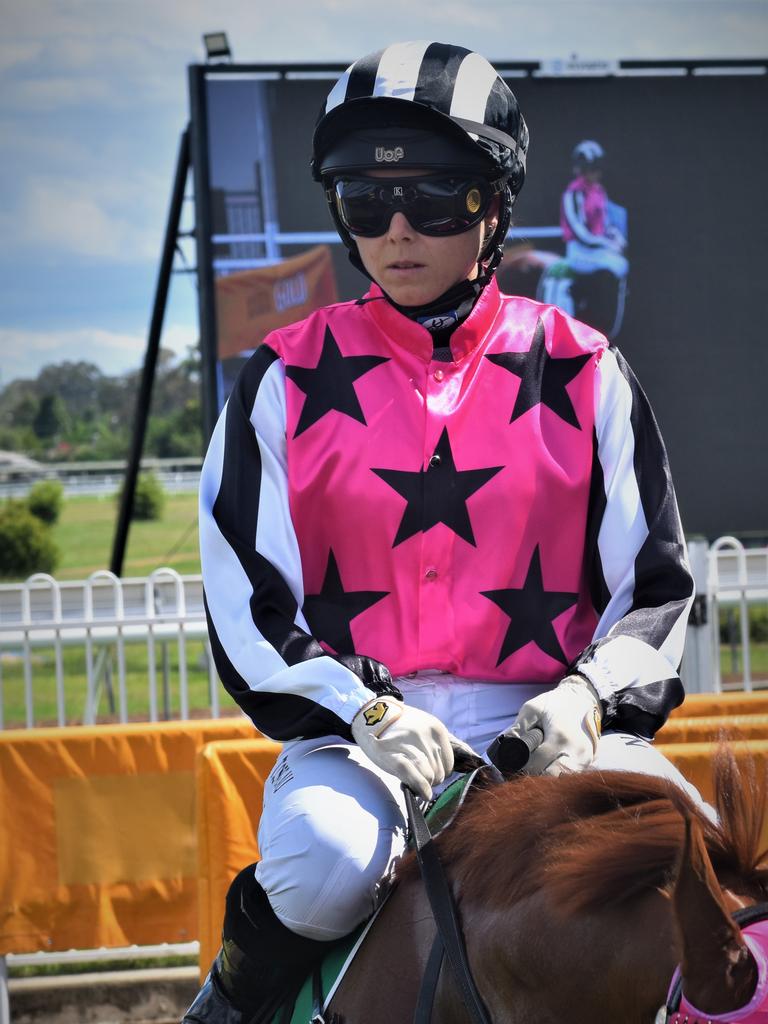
481, 546, 579, 666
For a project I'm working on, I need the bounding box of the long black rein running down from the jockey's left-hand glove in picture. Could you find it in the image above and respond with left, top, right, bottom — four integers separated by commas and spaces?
403, 785, 492, 1024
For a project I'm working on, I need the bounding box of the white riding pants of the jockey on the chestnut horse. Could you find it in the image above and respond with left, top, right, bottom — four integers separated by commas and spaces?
256, 672, 702, 940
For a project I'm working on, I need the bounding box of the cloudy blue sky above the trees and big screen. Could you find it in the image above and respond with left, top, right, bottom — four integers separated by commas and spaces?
0, 0, 768, 385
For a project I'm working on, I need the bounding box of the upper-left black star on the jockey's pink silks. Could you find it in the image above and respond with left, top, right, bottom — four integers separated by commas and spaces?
286, 327, 388, 437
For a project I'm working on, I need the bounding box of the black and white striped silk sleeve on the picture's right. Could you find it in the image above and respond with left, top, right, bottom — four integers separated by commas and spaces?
570, 348, 694, 736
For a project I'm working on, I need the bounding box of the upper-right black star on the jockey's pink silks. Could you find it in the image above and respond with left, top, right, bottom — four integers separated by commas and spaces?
485, 321, 592, 430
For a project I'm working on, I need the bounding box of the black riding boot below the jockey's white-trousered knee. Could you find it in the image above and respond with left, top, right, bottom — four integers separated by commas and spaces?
181, 864, 328, 1024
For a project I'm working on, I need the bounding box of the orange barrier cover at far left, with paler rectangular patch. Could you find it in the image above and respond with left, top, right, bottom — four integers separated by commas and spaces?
0, 718, 256, 954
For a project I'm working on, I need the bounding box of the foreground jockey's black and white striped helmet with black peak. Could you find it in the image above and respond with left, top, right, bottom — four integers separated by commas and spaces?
311, 41, 528, 272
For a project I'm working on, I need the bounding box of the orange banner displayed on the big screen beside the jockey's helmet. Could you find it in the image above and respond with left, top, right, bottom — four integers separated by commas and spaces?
216, 246, 338, 359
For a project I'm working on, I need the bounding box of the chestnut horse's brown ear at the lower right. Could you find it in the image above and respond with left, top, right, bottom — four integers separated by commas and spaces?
673, 817, 758, 1014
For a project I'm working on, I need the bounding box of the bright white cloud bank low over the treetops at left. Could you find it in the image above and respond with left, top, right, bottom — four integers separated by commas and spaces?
0, 324, 198, 386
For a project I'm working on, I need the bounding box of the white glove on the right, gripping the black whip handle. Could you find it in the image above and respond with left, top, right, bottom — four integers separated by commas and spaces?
509, 676, 602, 775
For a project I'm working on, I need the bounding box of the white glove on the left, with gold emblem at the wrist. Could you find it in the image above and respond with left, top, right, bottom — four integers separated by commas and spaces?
352, 697, 458, 800
